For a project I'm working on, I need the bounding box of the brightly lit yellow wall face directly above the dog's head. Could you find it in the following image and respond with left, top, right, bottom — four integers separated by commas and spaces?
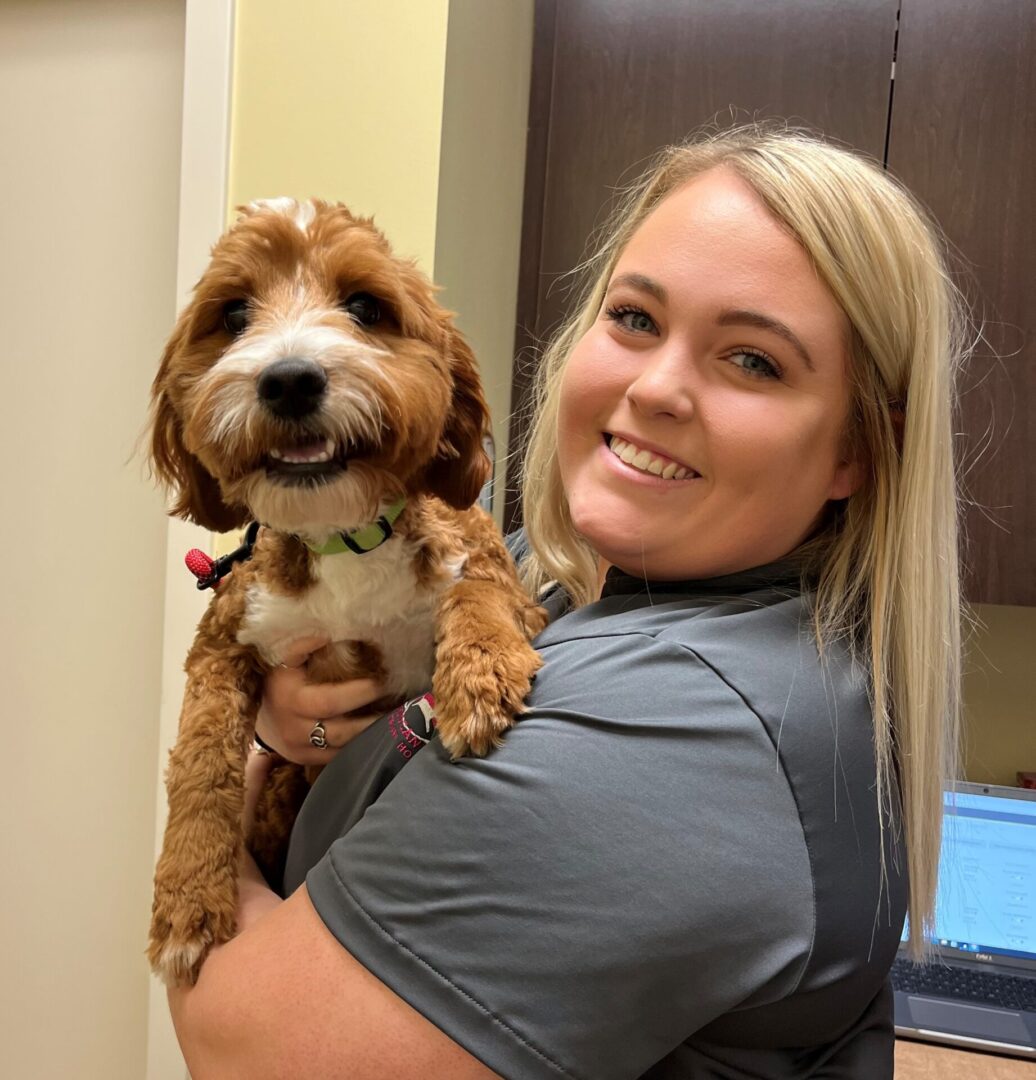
228, 0, 449, 267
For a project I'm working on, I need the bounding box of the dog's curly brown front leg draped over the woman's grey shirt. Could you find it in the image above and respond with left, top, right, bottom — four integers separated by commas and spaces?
432, 535, 547, 758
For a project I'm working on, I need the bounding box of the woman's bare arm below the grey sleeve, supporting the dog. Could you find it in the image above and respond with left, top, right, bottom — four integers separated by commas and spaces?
170, 755, 495, 1080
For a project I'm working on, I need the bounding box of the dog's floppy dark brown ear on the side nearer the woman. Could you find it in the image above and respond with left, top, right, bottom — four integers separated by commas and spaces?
426, 324, 493, 510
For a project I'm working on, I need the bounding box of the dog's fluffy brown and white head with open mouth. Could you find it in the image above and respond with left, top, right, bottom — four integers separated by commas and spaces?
151, 199, 489, 535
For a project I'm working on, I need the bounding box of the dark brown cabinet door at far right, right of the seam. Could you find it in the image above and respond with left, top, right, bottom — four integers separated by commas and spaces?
888, 0, 1036, 605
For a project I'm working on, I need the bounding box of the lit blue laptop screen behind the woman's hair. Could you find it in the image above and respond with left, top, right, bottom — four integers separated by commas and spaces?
904, 784, 1036, 961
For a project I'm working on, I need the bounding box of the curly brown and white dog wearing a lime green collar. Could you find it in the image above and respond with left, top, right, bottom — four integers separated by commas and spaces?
148, 199, 546, 985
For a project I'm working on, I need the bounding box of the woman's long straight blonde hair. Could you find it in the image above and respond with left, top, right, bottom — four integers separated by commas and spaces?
523, 124, 968, 957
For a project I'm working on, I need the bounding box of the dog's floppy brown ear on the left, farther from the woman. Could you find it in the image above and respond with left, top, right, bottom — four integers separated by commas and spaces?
149, 320, 248, 532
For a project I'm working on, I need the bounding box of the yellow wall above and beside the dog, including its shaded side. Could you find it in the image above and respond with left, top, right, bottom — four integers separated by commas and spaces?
226, 0, 533, 551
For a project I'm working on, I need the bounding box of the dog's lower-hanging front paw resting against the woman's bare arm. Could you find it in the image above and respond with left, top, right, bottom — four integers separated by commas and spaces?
148, 886, 236, 986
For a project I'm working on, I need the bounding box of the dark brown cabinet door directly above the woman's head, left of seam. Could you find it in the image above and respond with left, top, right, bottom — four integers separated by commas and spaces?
507, 0, 898, 525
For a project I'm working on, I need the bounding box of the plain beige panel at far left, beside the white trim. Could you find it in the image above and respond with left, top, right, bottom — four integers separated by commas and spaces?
0, 0, 184, 1080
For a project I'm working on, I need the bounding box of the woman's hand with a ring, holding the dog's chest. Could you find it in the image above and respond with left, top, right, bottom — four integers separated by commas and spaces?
255, 637, 385, 765
